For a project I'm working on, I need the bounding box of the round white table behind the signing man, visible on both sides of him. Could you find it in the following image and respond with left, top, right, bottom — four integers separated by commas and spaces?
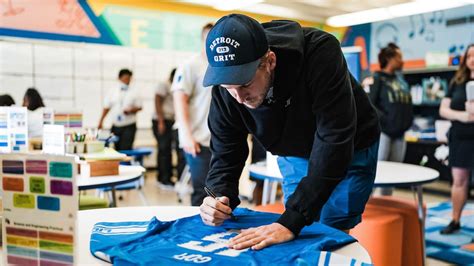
249, 161, 439, 264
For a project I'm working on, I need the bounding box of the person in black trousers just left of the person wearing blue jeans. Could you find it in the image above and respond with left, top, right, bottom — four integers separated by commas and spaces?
152, 68, 184, 188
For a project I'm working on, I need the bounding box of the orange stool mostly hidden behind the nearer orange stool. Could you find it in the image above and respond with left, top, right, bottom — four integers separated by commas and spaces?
366, 196, 423, 265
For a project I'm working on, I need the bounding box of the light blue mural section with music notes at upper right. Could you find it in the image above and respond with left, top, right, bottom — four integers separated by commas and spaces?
342, 5, 474, 73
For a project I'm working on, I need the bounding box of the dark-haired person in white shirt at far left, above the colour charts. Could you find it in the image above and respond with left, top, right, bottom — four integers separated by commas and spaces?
23, 88, 44, 138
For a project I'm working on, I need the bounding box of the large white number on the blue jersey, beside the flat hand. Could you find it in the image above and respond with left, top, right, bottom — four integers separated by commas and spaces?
178, 230, 248, 257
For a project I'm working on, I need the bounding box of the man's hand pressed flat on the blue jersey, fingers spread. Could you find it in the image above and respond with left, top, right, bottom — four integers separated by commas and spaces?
229, 223, 295, 250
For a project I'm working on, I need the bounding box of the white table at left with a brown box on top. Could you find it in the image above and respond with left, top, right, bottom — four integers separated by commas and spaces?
77, 165, 145, 207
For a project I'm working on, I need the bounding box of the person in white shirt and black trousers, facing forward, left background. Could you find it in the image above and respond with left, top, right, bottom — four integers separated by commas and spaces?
99, 69, 142, 150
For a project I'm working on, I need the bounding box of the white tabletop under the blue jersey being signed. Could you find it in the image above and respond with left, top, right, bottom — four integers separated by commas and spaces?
76, 206, 371, 265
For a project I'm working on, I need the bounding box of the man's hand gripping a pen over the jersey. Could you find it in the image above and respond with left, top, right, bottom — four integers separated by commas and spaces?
199, 197, 232, 226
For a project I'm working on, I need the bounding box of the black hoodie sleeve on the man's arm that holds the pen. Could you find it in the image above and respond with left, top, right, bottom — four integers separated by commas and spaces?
206, 86, 249, 209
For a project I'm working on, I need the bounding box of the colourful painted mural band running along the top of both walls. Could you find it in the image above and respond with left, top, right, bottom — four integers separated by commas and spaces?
0, 0, 474, 66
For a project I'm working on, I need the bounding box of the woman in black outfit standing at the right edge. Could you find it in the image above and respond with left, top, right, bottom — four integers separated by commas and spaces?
439, 44, 474, 234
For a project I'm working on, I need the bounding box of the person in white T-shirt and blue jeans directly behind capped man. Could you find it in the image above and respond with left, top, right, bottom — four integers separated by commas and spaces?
171, 23, 213, 206
